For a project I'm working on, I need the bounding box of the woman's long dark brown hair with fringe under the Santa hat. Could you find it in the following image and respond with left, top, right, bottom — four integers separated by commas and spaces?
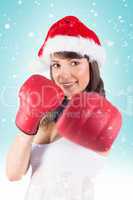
40, 51, 105, 126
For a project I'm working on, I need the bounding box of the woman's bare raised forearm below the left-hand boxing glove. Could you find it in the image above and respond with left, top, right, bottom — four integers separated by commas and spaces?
6, 133, 34, 181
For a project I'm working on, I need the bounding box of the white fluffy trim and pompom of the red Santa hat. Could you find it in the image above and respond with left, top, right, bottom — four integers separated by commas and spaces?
30, 35, 105, 77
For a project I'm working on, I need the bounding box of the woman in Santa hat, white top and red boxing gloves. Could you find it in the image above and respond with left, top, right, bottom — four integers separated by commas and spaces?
7, 16, 121, 200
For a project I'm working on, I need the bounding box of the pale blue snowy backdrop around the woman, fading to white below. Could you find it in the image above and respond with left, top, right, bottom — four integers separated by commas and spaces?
0, 0, 133, 180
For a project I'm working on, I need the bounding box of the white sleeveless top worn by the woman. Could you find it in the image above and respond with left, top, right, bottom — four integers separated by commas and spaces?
25, 137, 106, 200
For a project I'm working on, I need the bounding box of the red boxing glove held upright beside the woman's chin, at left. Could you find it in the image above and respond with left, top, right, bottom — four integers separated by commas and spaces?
16, 75, 64, 135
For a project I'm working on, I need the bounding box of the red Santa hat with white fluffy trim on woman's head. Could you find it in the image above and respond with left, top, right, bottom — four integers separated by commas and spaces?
29, 16, 105, 76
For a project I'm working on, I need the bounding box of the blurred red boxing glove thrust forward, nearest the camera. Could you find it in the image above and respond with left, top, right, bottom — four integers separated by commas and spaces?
57, 92, 122, 152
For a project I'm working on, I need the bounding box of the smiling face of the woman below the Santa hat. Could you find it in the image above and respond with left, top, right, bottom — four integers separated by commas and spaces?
51, 54, 90, 99
